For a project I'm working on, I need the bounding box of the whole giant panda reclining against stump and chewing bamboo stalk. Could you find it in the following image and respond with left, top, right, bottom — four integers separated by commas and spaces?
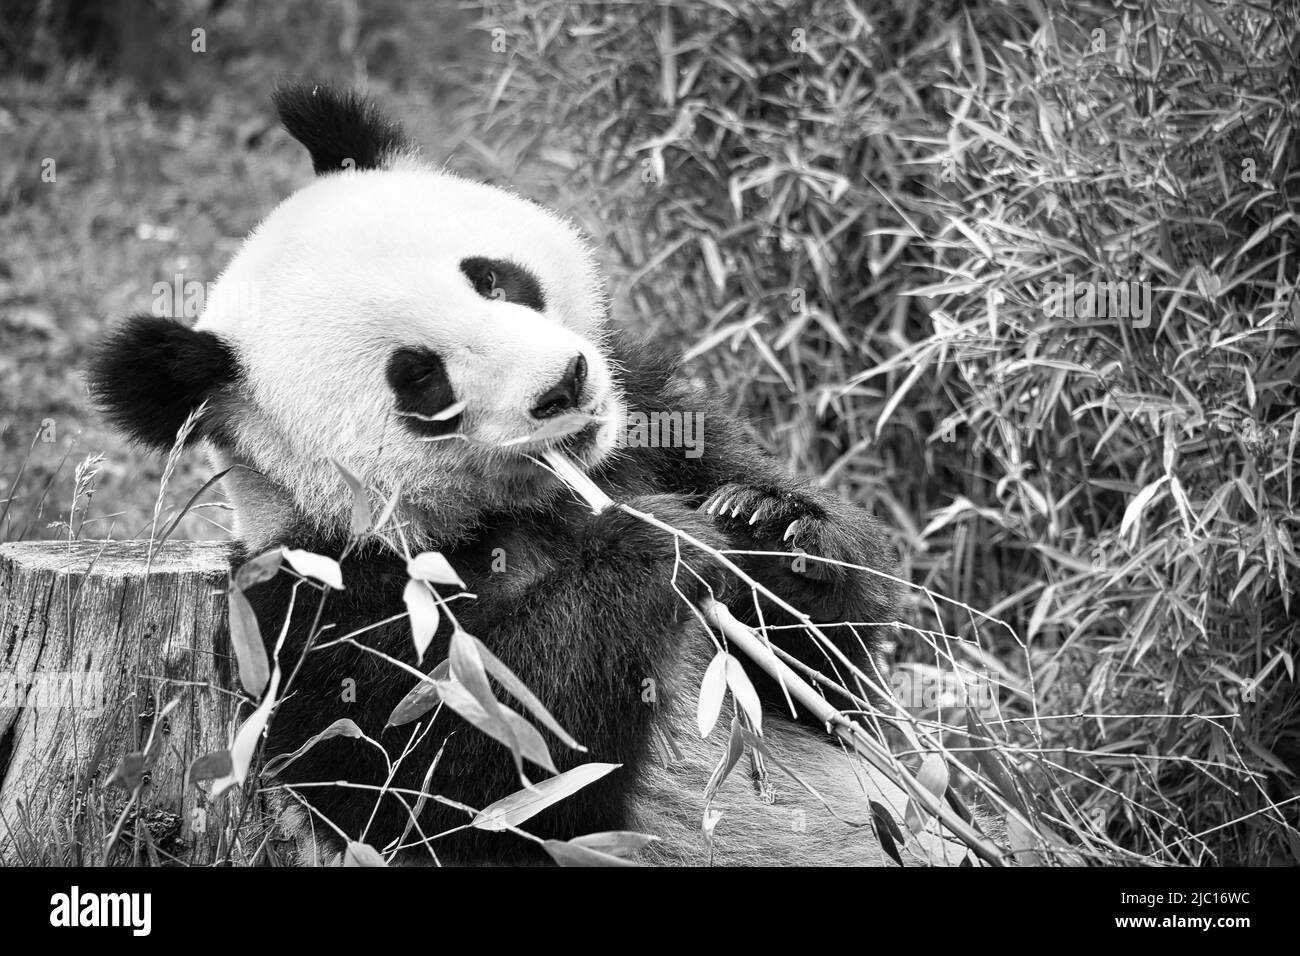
88, 85, 956, 865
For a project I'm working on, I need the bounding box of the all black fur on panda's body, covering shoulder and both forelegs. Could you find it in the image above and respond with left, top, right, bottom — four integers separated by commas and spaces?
239, 338, 893, 862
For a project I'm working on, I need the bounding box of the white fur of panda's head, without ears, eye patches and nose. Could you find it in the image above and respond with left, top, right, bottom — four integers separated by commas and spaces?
198, 167, 623, 546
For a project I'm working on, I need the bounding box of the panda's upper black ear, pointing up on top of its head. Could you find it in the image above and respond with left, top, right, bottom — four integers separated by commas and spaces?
270, 83, 417, 176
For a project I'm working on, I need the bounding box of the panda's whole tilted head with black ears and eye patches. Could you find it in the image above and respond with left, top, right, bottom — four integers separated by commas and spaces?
90, 85, 625, 542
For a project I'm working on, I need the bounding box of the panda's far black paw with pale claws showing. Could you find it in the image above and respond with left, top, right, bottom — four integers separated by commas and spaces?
699, 484, 842, 581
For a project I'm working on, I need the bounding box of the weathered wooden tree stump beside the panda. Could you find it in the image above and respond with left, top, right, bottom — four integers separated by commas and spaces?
0, 541, 238, 865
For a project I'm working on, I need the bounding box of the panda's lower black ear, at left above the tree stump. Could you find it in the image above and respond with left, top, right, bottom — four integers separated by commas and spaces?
87, 315, 239, 449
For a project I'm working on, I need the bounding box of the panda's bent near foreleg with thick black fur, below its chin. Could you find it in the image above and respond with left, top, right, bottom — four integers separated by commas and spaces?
445, 494, 729, 839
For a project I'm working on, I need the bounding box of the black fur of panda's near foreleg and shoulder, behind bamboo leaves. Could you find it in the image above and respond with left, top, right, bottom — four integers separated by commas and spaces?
250, 496, 725, 862
